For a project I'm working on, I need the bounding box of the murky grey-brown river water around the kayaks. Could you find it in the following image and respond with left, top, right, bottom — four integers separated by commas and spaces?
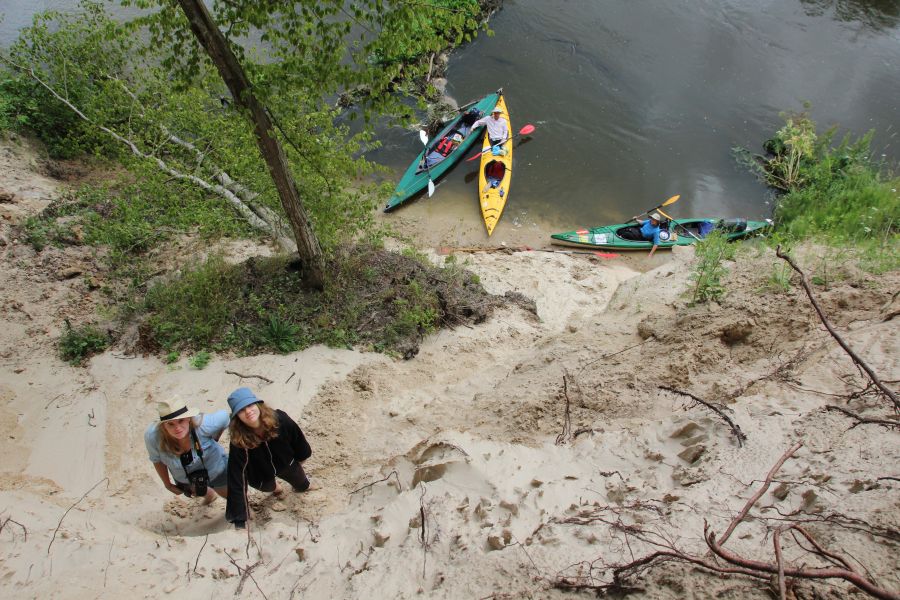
0, 0, 900, 244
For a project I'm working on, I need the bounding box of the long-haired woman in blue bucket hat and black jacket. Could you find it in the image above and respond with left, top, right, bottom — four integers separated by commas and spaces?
225, 387, 312, 529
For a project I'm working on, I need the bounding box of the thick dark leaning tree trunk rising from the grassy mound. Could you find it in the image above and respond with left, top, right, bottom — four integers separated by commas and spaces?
178, 0, 325, 289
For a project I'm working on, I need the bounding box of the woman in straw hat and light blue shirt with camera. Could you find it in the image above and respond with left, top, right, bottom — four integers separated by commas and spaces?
144, 396, 228, 504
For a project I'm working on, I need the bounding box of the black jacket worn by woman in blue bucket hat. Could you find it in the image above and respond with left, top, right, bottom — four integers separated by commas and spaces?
225, 409, 312, 523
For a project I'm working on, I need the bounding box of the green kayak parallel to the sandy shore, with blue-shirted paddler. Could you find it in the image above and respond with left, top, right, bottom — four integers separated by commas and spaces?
550, 219, 772, 250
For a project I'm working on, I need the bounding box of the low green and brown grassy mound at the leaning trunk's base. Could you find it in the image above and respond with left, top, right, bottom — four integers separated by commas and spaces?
141, 247, 488, 355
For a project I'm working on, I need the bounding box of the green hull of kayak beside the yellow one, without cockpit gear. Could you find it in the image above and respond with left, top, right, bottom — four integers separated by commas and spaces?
384, 90, 501, 212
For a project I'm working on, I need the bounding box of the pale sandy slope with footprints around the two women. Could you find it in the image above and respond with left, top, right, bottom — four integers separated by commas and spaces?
0, 137, 900, 599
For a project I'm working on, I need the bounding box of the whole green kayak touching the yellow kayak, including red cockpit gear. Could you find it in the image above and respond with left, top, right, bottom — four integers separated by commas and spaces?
384, 88, 503, 212
